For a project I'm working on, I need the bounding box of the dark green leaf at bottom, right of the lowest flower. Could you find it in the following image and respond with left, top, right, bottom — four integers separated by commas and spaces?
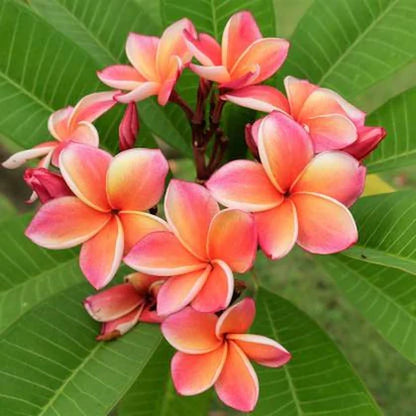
253, 288, 381, 416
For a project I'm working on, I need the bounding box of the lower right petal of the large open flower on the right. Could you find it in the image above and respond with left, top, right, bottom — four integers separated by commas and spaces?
291, 192, 358, 254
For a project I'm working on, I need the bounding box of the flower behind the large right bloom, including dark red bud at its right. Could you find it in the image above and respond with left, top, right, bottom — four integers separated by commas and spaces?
222, 77, 386, 160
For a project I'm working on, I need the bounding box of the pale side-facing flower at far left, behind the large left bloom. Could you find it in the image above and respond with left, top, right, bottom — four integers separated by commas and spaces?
3, 91, 118, 169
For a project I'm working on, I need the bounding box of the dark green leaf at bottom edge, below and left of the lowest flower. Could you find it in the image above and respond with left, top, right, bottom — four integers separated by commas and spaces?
117, 341, 211, 416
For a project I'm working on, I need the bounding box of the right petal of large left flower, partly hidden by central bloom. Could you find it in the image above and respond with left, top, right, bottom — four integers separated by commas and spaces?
118, 211, 169, 254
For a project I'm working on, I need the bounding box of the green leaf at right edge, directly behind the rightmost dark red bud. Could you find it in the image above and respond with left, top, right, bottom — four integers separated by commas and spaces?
365, 88, 416, 172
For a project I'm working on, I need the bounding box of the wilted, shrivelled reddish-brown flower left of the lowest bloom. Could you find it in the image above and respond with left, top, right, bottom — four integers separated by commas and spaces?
84, 273, 166, 341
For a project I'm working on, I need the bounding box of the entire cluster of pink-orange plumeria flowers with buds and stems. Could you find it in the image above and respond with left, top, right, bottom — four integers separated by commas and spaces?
3, 12, 385, 411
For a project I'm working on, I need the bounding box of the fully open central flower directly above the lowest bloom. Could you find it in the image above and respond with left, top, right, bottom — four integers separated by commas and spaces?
124, 180, 257, 315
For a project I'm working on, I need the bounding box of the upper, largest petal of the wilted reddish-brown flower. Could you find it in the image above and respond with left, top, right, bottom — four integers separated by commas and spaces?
84, 283, 143, 322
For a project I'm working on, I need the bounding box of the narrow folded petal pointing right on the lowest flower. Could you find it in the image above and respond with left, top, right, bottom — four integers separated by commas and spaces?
227, 334, 291, 367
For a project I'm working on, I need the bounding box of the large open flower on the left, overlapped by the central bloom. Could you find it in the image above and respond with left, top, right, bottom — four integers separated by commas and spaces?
26, 143, 168, 289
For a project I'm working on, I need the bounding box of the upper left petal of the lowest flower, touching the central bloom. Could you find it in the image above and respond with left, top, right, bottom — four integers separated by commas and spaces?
160, 307, 223, 354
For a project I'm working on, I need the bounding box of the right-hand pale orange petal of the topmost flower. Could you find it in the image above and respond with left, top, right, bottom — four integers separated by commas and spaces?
228, 38, 289, 84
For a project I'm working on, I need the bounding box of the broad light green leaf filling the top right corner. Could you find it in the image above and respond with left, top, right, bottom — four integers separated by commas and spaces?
280, 0, 416, 98
